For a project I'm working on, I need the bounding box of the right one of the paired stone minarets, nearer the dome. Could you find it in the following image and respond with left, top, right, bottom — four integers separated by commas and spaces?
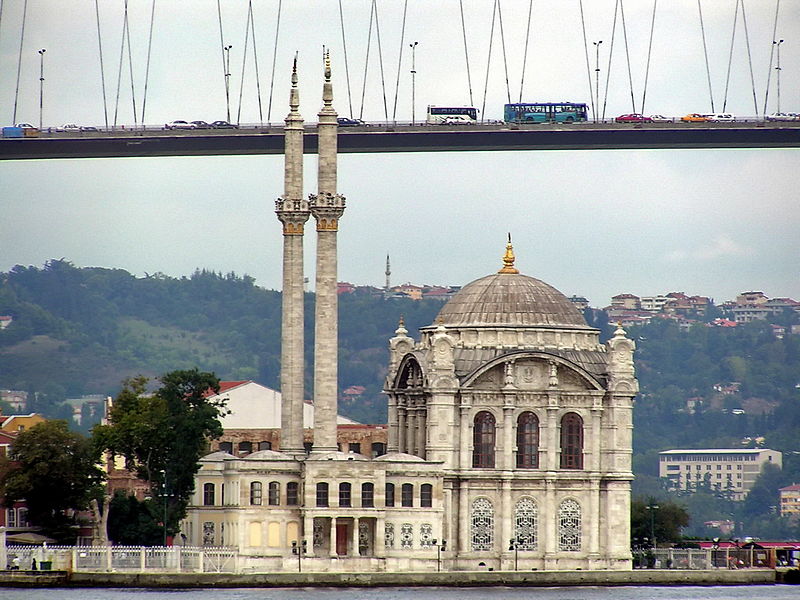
309, 51, 345, 452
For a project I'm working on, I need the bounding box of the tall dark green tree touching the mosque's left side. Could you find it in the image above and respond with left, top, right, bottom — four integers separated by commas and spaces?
93, 369, 230, 548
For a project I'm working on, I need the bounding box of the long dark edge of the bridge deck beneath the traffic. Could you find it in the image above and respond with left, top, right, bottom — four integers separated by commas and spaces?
0, 124, 800, 160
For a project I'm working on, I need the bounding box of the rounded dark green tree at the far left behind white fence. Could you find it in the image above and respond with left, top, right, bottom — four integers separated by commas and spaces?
0, 421, 104, 543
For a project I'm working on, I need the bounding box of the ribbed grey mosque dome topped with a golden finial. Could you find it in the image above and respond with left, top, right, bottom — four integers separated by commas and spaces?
436, 239, 588, 329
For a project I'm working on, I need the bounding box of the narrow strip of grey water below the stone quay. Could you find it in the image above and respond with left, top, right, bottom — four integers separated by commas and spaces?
0, 585, 800, 600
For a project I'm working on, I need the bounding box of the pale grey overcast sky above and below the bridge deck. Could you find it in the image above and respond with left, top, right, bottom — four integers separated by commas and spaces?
0, 0, 800, 305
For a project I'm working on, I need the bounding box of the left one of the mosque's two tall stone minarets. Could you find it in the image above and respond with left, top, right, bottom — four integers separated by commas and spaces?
275, 56, 309, 454
